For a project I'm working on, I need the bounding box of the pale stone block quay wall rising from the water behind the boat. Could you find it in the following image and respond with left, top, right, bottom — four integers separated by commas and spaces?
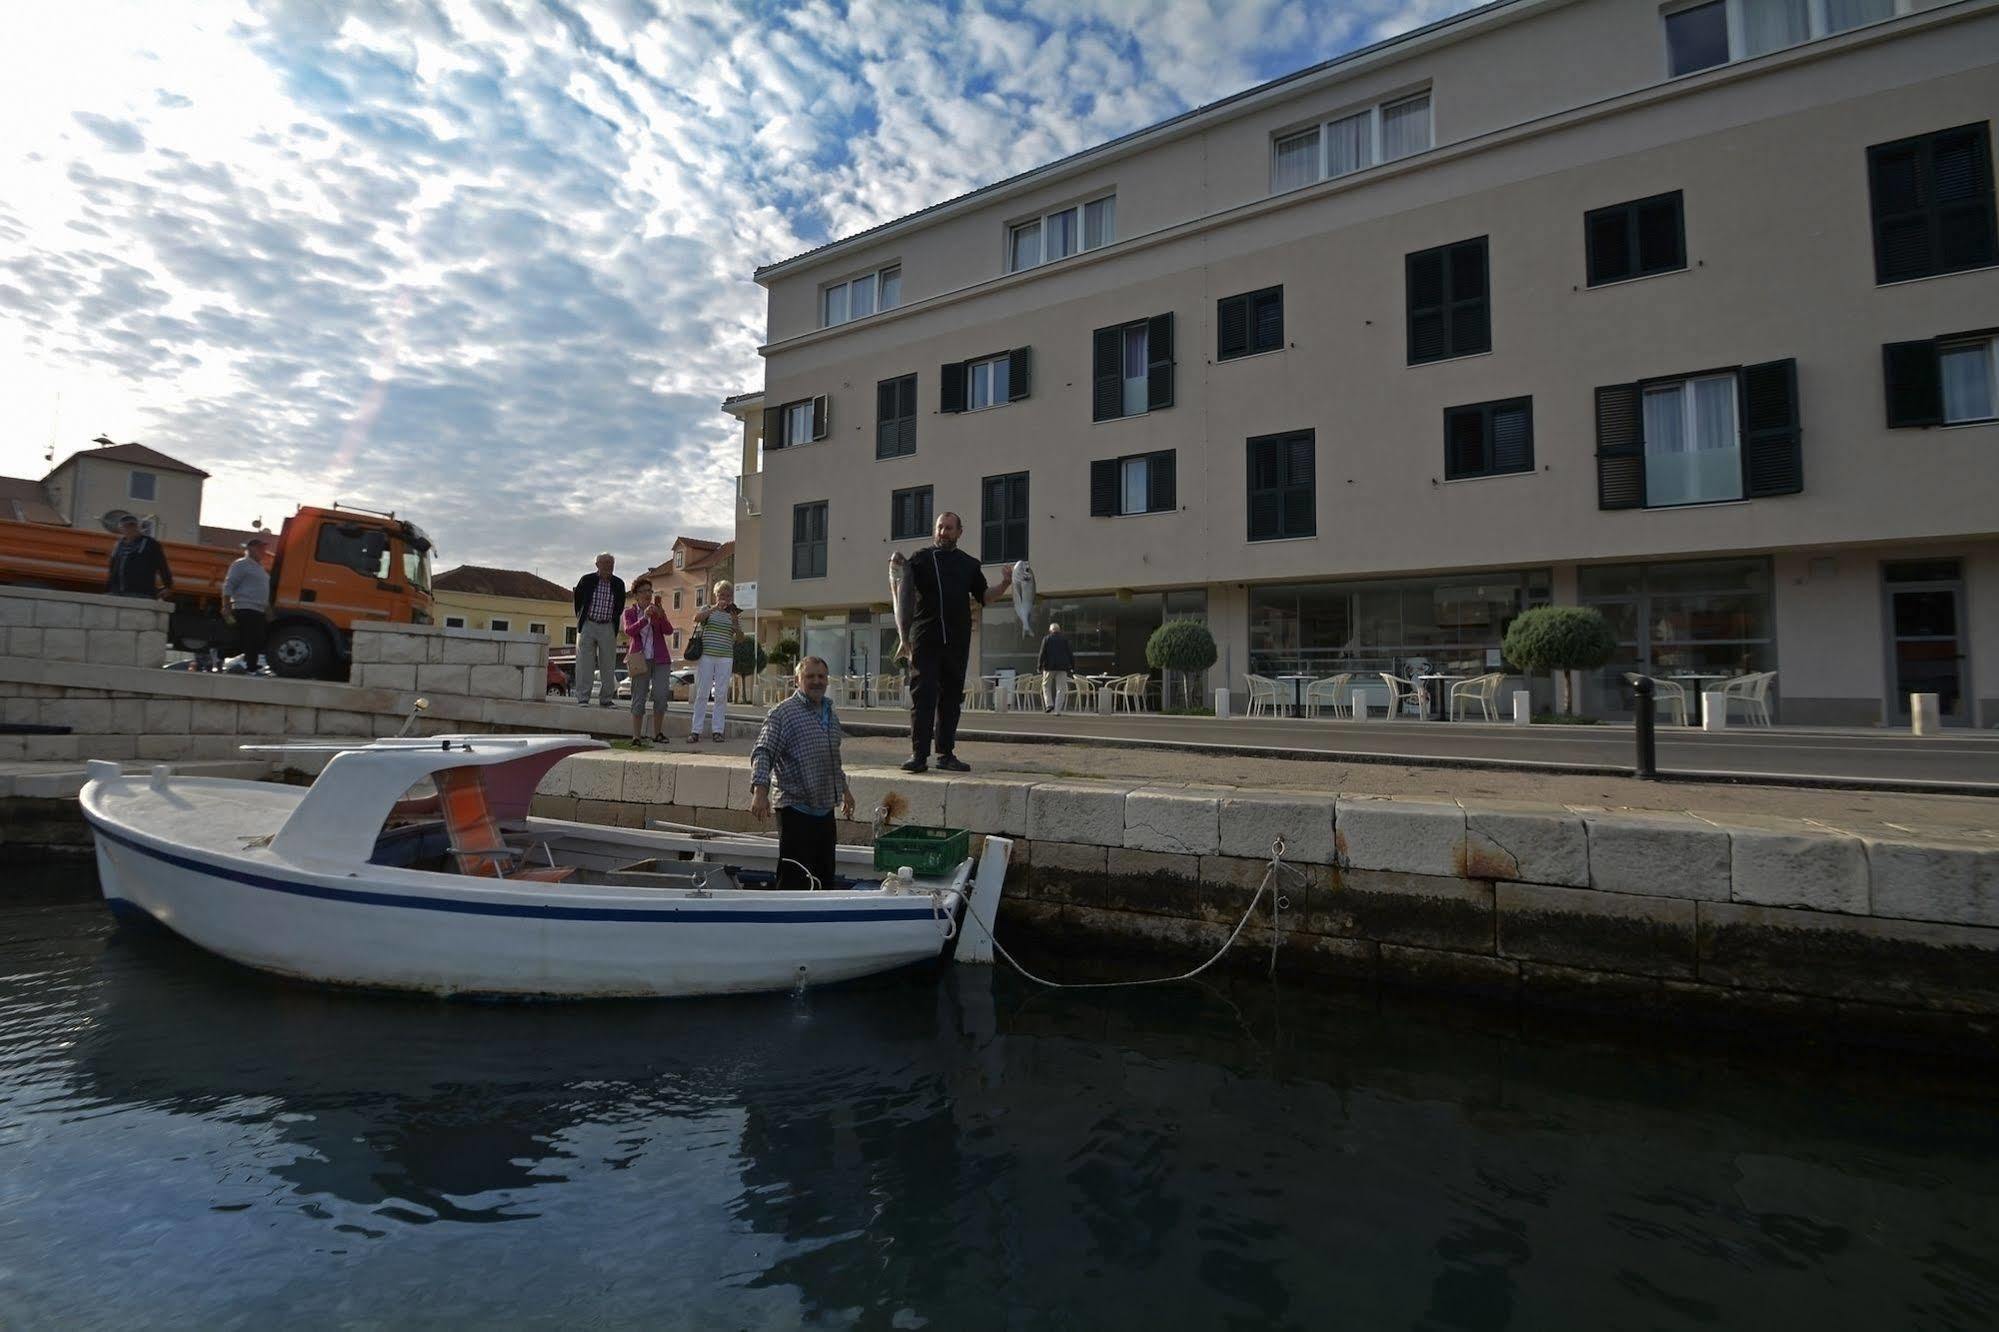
536, 754, 1999, 1048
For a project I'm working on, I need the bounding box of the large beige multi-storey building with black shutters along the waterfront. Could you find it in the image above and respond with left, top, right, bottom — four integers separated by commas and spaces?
747, 0, 1999, 726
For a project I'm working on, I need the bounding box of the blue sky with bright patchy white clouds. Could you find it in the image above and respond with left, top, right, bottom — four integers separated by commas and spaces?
0, 0, 1471, 580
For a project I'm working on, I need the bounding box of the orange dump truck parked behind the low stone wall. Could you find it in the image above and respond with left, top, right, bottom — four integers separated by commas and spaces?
0, 506, 430, 680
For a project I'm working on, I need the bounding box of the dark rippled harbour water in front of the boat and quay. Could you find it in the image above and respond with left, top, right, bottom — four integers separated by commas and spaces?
0, 864, 1999, 1330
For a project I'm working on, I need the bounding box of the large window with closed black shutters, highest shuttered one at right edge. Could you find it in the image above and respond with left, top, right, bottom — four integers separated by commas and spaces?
1867, 122, 1999, 282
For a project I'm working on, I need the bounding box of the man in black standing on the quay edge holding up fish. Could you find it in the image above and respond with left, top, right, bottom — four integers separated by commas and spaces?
902, 512, 1013, 772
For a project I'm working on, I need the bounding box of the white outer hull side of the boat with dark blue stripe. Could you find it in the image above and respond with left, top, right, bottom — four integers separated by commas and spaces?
92, 818, 964, 998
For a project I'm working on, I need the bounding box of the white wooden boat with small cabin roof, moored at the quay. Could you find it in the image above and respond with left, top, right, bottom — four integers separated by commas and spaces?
82, 736, 1009, 998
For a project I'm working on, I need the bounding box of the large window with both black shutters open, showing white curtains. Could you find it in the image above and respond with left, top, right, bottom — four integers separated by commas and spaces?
1597, 360, 1805, 508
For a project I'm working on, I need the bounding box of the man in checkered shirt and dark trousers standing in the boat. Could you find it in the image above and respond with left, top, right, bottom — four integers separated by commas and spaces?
750, 656, 854, 888
